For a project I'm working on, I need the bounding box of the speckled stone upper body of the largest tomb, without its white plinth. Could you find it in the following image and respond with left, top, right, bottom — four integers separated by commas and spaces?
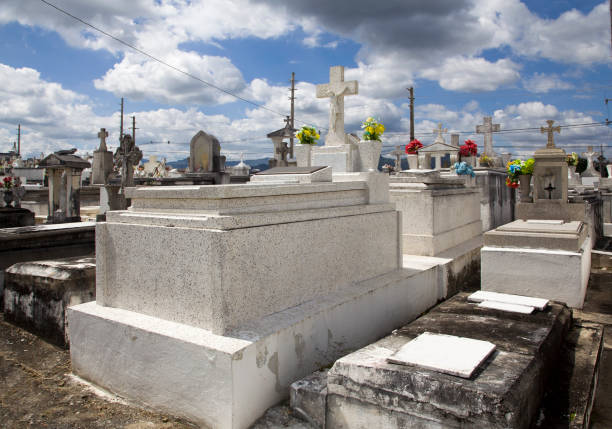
96, 182, 401, 334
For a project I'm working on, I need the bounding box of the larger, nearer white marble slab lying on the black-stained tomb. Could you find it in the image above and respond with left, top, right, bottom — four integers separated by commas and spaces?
387, 332, 495, 378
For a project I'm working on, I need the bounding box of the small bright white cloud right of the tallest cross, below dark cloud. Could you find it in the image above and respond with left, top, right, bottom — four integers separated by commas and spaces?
421, 57, 520, 92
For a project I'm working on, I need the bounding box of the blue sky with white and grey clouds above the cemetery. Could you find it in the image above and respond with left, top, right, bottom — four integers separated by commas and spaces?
0, 0, 612, 161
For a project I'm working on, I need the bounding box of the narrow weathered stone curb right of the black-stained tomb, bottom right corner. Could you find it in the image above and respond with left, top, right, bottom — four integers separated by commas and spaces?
534, 322, 609, 429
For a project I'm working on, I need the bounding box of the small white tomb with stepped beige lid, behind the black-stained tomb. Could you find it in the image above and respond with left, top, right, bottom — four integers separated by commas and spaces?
481, 220, 592, 308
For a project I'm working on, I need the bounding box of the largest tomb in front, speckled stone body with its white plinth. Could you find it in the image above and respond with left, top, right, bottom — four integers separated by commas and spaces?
68, 176, 439, 428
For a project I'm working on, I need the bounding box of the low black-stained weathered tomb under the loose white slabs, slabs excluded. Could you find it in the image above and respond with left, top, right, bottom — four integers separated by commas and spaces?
326, 294, 571, 429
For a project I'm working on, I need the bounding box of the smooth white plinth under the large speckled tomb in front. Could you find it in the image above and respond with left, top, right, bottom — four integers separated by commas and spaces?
68, 268, 439, 428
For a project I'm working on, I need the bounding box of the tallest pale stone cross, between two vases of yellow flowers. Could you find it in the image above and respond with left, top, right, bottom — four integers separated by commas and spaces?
317, 66, 359, 146
